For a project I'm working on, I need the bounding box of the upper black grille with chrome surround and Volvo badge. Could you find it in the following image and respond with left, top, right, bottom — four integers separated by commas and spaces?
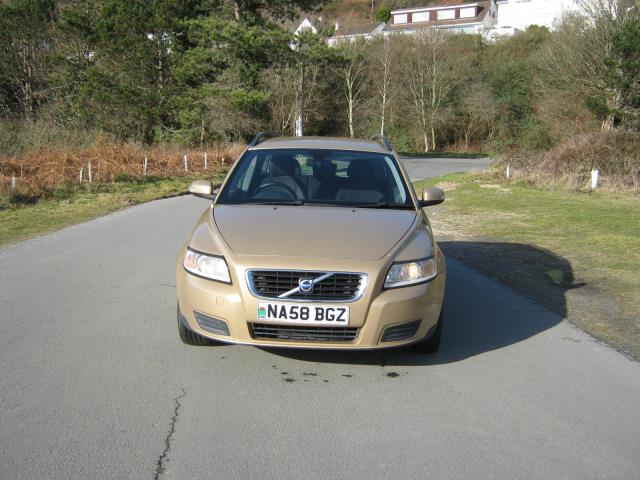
247, 270, 367, 302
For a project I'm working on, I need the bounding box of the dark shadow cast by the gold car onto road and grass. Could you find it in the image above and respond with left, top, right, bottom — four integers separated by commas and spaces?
265, 242, 584, 366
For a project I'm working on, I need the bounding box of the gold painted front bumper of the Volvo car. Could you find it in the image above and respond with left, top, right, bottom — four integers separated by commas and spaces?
176, 251, 445, 350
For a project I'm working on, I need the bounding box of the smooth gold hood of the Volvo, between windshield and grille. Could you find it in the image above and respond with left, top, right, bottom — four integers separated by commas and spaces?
213, 205, 417, 260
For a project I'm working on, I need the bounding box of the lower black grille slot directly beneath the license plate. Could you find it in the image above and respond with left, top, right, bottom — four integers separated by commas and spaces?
250, 323, 358, 342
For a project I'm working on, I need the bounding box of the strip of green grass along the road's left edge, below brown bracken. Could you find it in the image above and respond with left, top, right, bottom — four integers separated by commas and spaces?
0, 177, 221, 245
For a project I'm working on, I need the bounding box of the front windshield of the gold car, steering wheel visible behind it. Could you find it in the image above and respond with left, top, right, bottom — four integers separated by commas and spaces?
218, 149, 413, 208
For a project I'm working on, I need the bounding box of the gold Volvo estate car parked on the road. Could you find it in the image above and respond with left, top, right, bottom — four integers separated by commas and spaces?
176, 134, 445, 353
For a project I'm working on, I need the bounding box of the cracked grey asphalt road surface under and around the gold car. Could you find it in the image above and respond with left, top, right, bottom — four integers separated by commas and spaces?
0, 160, 640, 480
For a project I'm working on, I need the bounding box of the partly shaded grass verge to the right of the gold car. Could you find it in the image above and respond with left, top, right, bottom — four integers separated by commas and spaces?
415, 172, 640, 358
